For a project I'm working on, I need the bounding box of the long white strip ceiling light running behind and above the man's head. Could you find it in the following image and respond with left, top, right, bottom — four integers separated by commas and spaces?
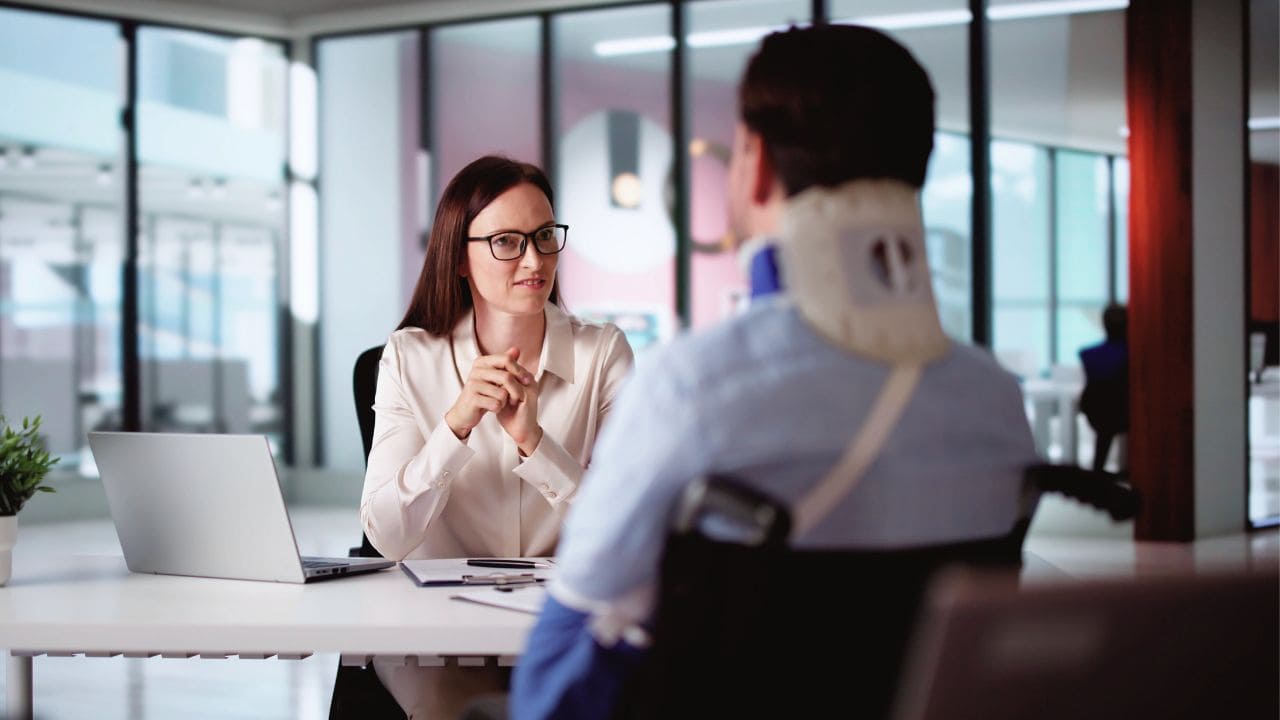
594, 0, 1129, 58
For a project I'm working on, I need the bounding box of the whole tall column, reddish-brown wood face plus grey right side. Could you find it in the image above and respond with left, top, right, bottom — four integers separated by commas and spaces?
1125, 0, 1245, 541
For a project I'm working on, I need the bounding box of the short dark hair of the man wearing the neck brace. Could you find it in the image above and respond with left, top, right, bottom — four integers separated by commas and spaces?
739, 24, 933, 196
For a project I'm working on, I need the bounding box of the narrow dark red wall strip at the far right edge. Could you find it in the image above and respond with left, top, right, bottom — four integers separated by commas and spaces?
1249, 163, 1280, 323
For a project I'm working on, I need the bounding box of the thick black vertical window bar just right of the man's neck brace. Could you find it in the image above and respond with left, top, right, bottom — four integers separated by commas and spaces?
969, 0, 992, 347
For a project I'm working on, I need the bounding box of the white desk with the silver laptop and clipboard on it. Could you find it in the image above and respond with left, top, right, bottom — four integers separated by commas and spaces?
0, 545, 534, 719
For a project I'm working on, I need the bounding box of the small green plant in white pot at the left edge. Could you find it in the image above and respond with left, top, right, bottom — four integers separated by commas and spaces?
0, 415, 58, 585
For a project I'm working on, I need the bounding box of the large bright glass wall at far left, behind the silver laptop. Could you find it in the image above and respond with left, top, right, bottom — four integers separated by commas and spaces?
0, 9, 287, 475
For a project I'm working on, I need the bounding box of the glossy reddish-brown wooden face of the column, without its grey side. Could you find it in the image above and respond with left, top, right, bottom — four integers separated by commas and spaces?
1125, 0, 1196, 541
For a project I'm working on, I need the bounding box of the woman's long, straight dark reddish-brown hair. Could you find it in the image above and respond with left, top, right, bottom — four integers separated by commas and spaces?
396, 155, 559, 337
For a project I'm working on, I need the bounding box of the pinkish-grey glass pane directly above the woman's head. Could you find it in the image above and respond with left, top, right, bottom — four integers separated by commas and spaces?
428, 18, 543, 206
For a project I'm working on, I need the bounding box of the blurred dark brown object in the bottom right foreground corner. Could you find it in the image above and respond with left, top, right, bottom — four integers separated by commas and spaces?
892, 566, 1280, 720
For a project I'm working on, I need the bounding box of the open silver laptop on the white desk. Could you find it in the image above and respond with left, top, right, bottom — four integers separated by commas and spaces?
88, 432, 396, 583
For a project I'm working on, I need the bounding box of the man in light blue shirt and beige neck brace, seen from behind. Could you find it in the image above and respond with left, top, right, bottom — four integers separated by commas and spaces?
511, 26, 1036, 717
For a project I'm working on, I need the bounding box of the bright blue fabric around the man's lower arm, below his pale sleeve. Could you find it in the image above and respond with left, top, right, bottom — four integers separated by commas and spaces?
511, 597, 644, 720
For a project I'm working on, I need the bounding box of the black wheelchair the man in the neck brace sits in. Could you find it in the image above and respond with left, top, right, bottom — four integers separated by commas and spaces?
616, 465, 1138, 719
